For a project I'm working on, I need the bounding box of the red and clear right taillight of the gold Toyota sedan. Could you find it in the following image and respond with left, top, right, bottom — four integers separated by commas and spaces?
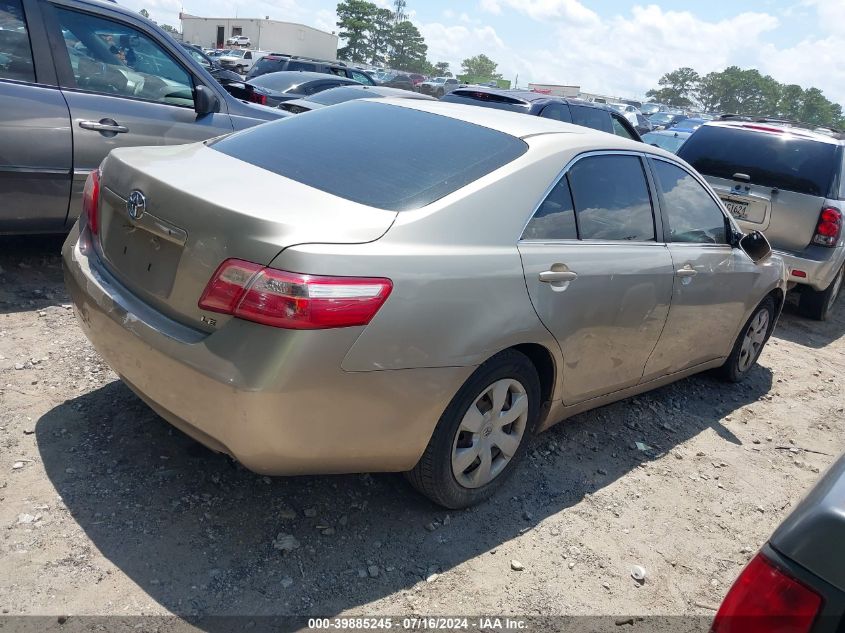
199, 259, 393, 330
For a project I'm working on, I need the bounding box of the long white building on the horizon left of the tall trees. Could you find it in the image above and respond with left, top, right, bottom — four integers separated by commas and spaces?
179, 13, 338, 59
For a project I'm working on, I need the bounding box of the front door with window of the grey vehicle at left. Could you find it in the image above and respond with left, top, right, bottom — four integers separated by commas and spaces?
47, 5, 233, 228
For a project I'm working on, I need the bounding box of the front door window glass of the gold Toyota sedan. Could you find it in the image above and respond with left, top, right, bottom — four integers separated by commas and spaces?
652, 160, 728, 244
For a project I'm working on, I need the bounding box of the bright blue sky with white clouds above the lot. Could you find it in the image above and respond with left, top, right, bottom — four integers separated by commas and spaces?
127, 0, 845, 104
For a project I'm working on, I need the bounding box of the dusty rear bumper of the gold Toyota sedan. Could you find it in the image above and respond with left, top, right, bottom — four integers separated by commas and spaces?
63, 229, 473, 475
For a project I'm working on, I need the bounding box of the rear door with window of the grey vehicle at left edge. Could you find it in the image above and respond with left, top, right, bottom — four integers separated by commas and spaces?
0, 0, 72, 233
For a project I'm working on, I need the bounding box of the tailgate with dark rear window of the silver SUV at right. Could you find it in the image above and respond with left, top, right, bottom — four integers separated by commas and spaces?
678, 124, 842, 251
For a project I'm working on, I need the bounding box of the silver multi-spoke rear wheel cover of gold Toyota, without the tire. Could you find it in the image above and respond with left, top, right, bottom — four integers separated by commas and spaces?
452, 378, 528, 488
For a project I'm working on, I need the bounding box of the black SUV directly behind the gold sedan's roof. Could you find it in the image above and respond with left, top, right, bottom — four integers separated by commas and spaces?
440, 86, 642, 142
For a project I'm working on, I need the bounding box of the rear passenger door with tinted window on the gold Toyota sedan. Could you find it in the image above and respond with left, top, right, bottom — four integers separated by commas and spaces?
519, 153, 672, 405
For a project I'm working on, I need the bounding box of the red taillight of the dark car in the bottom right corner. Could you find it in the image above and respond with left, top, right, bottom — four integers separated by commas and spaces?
710, 554, 822, 633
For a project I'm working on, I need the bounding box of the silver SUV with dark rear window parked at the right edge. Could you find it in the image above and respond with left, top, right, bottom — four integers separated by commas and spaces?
678, 119, 845, 321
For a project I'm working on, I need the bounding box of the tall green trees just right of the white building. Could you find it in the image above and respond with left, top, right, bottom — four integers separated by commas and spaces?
337, 0, 501, 81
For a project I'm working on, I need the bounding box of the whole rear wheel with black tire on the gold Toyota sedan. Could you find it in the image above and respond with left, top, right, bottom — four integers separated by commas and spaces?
406, 350, 540, 509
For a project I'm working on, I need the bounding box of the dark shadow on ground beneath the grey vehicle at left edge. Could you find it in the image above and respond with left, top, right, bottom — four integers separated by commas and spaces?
0, 235, 68, 314
